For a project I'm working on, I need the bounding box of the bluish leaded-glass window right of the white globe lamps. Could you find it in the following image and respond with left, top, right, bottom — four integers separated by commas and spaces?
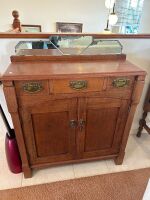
116, 0, 144, 33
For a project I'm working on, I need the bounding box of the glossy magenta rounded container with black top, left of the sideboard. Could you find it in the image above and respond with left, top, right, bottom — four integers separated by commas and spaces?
5, 133, 22, 174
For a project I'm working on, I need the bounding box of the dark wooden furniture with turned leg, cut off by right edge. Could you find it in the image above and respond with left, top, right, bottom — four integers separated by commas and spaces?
137, 85, 150, 137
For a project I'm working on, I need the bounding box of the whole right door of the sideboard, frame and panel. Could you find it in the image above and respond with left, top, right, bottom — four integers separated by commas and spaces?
78, 98, 128, 158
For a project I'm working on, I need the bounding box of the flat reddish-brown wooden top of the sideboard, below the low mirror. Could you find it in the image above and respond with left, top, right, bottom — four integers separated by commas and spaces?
2, 60, 146, 80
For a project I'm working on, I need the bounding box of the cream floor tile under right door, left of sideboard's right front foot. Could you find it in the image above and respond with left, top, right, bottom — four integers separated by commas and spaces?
73, 161, 109, 178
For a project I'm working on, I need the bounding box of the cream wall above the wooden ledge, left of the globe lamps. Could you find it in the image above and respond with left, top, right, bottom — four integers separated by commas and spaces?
0, 0, 108, 32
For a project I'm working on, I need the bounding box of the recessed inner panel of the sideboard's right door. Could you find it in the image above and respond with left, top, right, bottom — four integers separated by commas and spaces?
85, 107, 119, 152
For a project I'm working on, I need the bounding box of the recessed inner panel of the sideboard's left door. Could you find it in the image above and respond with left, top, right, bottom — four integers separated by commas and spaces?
32, 112, 69, 157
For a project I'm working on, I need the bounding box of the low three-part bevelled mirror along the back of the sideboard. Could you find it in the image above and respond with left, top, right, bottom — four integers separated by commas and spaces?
15, 35, 123, 56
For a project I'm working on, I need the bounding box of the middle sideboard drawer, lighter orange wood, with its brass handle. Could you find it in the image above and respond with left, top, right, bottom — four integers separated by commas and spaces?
51, 78, 104, 94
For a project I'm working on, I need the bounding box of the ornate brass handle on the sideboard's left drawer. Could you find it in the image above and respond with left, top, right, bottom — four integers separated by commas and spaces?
22, 82, 43, 93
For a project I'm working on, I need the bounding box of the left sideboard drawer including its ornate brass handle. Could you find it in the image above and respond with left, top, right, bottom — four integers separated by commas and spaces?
15, 80, 49, 96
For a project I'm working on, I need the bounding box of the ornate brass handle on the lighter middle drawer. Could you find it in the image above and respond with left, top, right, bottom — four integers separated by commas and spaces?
69, 80, 88, 90
